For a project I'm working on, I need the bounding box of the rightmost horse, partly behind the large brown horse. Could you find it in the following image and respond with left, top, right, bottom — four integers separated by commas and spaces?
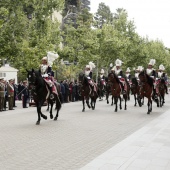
157, 78, 166, 107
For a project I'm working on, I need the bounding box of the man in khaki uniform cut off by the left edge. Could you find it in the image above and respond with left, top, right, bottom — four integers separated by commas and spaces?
0, 78, 5, 112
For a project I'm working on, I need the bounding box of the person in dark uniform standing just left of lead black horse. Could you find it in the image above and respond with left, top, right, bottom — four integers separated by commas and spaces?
22, 81, 29, 108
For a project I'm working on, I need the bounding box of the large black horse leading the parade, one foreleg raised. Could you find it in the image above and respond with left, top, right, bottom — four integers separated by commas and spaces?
27, 69, 61, 125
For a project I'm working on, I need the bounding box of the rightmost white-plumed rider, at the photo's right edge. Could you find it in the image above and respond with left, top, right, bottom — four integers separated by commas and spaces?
156, 64, 168, 94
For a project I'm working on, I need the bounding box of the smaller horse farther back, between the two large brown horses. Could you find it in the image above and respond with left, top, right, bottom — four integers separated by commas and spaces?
130, 77, 144, 107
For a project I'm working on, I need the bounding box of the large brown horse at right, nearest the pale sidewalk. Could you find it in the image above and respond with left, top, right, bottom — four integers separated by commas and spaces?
139, 71, 154, 114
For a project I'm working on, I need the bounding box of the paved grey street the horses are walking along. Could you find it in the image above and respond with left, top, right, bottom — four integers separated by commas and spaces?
0, 95, 170, 170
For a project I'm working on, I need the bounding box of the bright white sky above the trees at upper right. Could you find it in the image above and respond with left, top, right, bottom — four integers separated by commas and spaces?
90, 0, 170, 48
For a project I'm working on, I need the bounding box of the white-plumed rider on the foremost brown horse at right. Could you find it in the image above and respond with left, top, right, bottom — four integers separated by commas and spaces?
146, 59, 156, 96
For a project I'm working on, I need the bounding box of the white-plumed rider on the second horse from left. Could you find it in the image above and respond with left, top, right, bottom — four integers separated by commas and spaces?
84, 61, 97, 94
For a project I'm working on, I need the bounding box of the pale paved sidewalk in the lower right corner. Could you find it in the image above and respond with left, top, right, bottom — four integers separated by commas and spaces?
81, 109, 170, 170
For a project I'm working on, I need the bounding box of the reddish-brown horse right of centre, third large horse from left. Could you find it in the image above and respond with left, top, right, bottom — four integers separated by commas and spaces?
108, 72, 127, 112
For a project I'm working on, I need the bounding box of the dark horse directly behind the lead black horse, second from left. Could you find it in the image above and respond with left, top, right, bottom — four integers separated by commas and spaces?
79, 73, 98, 112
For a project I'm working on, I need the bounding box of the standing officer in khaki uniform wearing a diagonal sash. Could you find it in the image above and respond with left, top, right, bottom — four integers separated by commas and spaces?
7, 79, 14, 110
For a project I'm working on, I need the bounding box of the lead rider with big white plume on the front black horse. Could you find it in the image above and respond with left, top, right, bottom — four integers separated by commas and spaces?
40, 52, 58, 99
